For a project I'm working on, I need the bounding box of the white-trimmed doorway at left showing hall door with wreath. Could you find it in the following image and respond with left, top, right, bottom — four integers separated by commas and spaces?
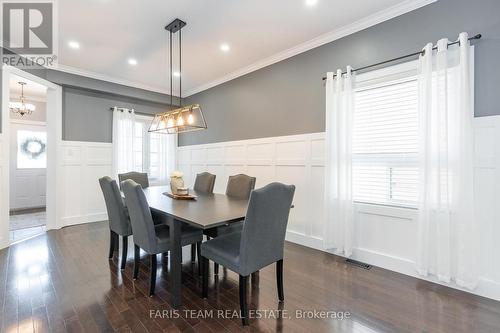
0, 66, 62, 248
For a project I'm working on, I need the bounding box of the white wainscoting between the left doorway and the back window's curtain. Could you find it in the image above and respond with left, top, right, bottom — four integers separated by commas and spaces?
61, 141, 112, 226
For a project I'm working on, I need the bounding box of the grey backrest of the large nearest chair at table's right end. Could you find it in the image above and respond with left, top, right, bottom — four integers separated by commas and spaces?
240, 183, 295, 275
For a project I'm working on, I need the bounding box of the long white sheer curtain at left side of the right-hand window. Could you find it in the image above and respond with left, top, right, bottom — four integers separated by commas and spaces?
324, 67, 354, 257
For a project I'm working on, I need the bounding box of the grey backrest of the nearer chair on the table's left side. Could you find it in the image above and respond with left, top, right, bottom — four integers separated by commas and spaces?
121, 179, 157, 254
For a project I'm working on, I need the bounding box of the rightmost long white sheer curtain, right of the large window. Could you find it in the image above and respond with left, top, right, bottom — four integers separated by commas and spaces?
417, 33, 479, 289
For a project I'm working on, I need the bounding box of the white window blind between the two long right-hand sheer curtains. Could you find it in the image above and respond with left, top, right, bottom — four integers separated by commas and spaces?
353, 77, 418, 207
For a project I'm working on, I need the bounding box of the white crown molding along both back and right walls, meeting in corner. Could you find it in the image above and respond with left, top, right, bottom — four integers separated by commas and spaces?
55, 0, 438, 97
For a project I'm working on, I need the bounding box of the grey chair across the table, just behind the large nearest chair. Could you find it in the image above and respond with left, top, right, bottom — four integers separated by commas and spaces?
203, 174, 256, 275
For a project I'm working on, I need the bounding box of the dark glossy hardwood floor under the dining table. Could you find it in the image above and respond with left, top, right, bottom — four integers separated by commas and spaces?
0, 222, 500, 333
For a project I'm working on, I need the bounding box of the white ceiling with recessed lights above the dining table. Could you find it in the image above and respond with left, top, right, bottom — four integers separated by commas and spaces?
58, 0, 433, 95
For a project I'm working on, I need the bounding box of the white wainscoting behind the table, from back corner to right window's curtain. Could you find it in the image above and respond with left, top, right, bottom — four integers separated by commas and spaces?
178, 133, 324, 249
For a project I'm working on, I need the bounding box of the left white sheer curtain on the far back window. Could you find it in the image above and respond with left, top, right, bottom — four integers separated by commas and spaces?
113, 107, 135, 179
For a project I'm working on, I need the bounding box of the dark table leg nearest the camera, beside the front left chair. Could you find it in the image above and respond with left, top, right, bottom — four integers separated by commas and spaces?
169, 219, 182, 308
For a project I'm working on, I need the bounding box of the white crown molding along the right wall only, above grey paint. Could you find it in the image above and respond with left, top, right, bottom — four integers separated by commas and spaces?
185, 0, 438, 97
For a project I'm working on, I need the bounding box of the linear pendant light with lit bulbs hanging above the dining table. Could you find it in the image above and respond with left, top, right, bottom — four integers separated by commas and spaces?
149, 19, 207, 134
